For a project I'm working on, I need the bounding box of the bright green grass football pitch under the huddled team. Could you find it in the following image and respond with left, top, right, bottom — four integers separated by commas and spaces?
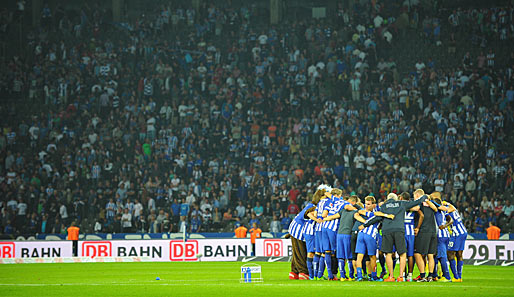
0, 262, 514, 297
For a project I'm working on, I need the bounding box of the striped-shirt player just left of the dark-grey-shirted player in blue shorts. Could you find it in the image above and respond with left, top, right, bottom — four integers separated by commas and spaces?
321, 189, 356, 280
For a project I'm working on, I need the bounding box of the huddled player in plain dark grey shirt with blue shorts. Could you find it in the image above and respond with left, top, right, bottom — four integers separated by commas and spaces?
323, 196, 356, 281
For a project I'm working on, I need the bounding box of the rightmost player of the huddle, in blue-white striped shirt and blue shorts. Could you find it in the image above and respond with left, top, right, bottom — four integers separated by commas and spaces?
443, 202, 468, 282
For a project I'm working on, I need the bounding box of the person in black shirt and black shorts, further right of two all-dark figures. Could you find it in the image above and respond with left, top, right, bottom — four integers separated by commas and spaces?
414, 189, 437, 282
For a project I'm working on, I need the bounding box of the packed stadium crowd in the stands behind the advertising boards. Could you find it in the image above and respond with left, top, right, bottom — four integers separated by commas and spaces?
0, 1, 514, 236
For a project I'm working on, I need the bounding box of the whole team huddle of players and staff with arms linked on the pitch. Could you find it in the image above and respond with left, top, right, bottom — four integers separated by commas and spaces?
289, 185, 467, 282
